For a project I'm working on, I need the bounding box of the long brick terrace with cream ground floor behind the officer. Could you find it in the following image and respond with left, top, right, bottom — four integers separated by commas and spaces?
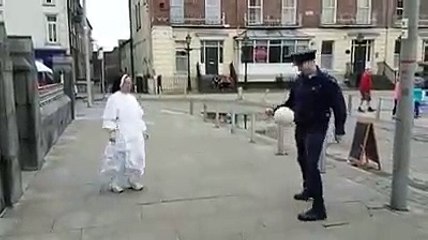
135, 0, 428, 89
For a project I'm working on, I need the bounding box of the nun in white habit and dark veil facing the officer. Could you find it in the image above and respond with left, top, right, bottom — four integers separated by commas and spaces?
101, 74, 148, 193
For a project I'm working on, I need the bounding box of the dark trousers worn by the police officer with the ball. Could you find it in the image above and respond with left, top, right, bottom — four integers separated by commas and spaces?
295, 126, 327, 208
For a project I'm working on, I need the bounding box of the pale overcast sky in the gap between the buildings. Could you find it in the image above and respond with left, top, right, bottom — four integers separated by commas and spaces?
86, 0, 129, 51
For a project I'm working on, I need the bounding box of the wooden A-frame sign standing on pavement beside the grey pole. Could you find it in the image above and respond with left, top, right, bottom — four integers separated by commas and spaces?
349, 118, 381, 170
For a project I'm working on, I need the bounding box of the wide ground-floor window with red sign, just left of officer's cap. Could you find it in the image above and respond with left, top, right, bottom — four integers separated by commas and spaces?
241, 40, 309, 64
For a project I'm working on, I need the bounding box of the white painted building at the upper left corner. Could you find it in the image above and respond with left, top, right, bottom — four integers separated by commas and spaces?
0, 0, 70, 66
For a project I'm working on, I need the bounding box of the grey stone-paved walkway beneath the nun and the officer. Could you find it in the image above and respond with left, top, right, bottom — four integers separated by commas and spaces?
0, 102, 428, 240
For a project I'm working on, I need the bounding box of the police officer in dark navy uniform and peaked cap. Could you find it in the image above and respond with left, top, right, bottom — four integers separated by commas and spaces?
266, 50, 346, 221
